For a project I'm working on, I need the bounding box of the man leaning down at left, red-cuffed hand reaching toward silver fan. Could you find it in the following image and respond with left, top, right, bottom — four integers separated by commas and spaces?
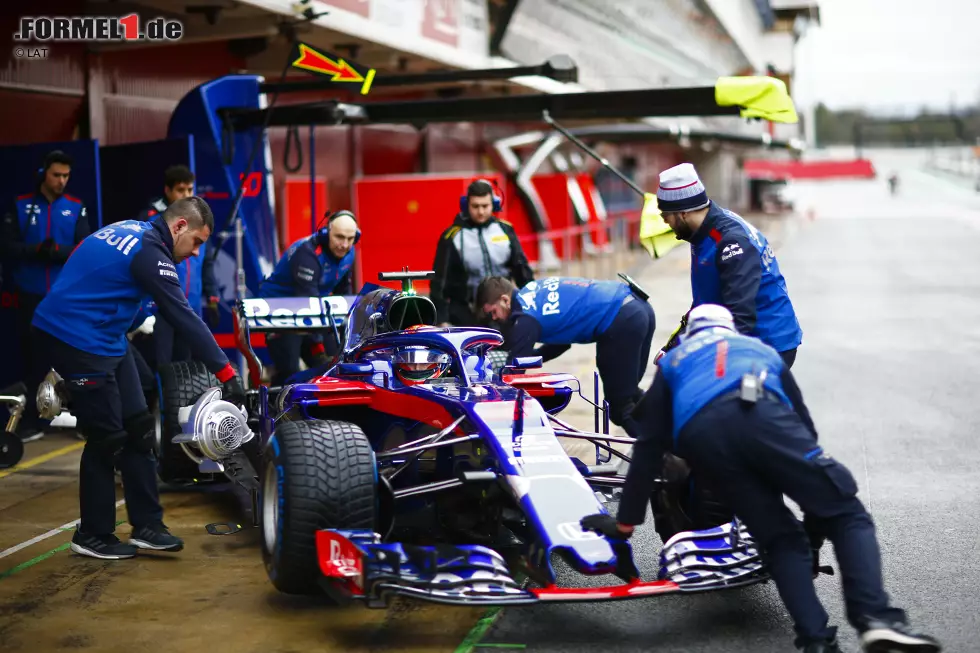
33, 197, 245, 560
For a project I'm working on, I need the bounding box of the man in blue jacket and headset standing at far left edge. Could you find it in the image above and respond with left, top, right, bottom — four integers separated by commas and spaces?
0, 150, 91, 442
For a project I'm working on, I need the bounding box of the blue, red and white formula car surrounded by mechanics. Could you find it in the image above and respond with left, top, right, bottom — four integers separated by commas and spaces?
168, 271, 768, 607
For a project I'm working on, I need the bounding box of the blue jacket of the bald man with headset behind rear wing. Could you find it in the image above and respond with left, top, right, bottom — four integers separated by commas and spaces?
259, 235, 354, 297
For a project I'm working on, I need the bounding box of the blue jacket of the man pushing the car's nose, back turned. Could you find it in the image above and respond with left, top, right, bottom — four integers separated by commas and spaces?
616, 333, 817, 525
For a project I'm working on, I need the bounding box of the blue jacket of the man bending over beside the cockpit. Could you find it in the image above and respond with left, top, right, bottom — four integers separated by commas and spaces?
508, 277, 631, 360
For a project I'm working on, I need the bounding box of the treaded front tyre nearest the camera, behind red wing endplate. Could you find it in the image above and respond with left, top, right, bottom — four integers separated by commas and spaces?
260, 420, 378, 594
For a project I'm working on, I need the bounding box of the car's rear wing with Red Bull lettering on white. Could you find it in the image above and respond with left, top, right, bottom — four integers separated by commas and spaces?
234, 295, 357, 388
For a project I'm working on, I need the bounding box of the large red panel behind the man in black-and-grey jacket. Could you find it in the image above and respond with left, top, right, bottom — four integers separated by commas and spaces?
353, 173, 510, 292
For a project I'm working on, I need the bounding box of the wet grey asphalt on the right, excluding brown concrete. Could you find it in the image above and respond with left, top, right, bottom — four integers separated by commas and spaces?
476, 152, 980, 653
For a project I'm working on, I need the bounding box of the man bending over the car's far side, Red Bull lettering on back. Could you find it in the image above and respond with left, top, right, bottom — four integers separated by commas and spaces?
477, 277, 656, 437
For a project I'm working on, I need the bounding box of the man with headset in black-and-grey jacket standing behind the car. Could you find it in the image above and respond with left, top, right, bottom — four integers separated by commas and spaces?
429, 179, 534, 326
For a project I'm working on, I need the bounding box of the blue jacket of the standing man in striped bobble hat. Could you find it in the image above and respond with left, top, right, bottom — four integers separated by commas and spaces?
691, 202, 803, 351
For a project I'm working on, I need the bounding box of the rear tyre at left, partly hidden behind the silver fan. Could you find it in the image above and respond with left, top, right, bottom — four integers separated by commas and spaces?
157, 361, 215, 483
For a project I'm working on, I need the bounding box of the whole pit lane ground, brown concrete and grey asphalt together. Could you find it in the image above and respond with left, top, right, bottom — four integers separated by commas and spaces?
0, 152, 980, 653
